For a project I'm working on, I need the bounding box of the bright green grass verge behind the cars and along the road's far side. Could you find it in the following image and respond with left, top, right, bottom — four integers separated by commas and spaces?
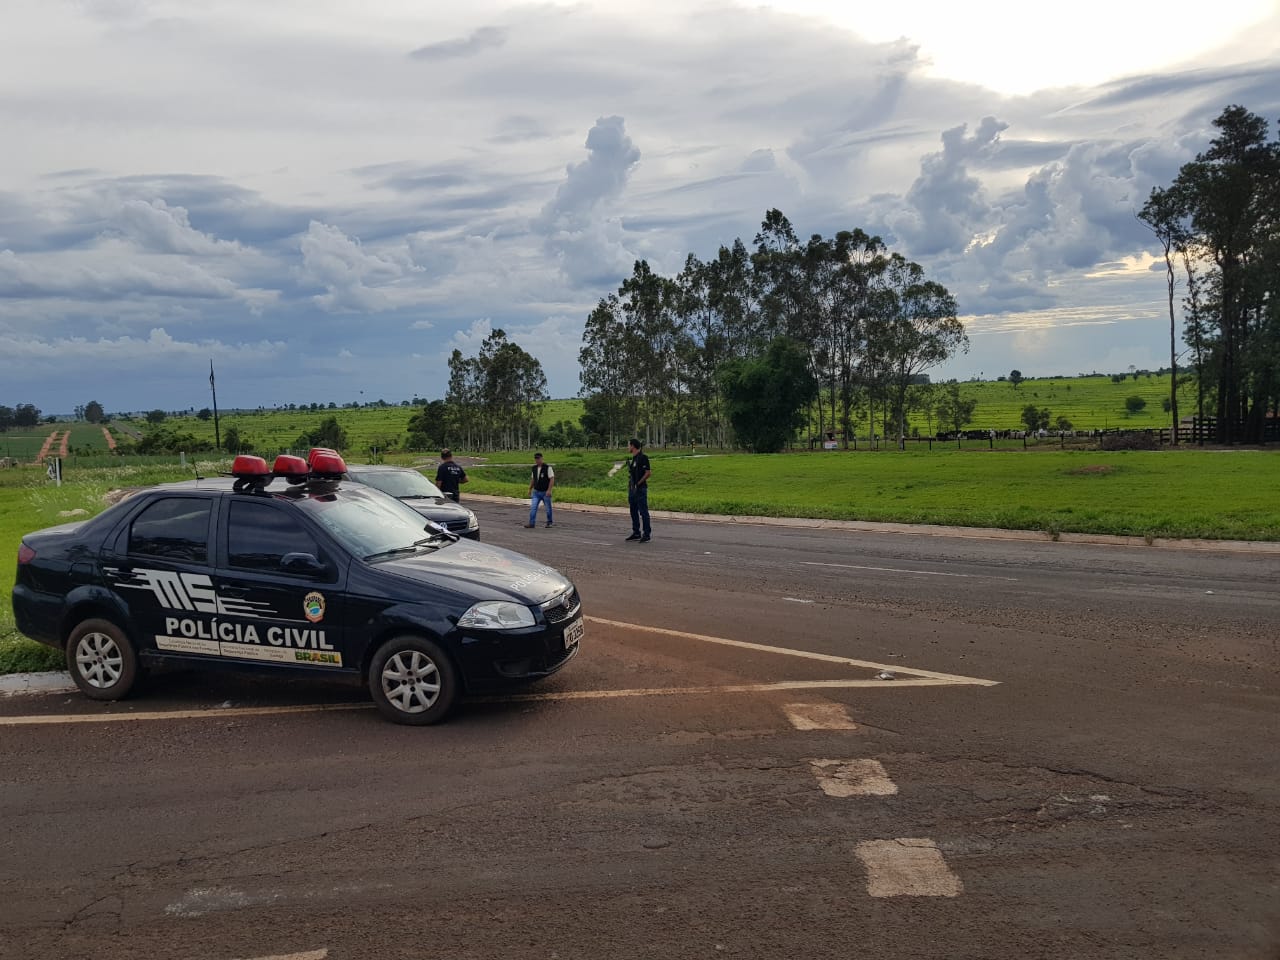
0, 445, 1280, 673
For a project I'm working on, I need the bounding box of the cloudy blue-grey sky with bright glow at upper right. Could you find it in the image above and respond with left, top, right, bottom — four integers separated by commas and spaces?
0, 0, 1280, 413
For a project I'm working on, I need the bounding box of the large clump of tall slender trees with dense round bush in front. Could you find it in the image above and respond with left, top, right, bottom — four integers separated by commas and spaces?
579, 209, 968, 449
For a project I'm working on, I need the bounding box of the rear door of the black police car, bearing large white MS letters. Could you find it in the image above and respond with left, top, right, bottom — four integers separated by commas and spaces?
102, 495, 218, 655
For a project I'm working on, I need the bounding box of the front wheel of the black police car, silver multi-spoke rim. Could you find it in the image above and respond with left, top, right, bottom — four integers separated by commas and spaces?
369, 636, 458, 727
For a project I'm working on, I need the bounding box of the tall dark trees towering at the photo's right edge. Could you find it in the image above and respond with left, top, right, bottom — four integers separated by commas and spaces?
1138, 106, 1280, 443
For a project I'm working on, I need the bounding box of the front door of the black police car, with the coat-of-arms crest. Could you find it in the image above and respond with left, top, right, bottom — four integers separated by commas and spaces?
215, 497, 360, 671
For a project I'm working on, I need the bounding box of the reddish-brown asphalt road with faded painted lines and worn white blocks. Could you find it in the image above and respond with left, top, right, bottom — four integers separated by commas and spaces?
0, 503, 1280, 960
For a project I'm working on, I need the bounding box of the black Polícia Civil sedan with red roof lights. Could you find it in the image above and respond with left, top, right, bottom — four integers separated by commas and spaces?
13, 449, 584, 724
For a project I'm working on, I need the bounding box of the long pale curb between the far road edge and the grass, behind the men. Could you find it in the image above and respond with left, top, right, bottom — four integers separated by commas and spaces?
465, 493, 1280, 556
